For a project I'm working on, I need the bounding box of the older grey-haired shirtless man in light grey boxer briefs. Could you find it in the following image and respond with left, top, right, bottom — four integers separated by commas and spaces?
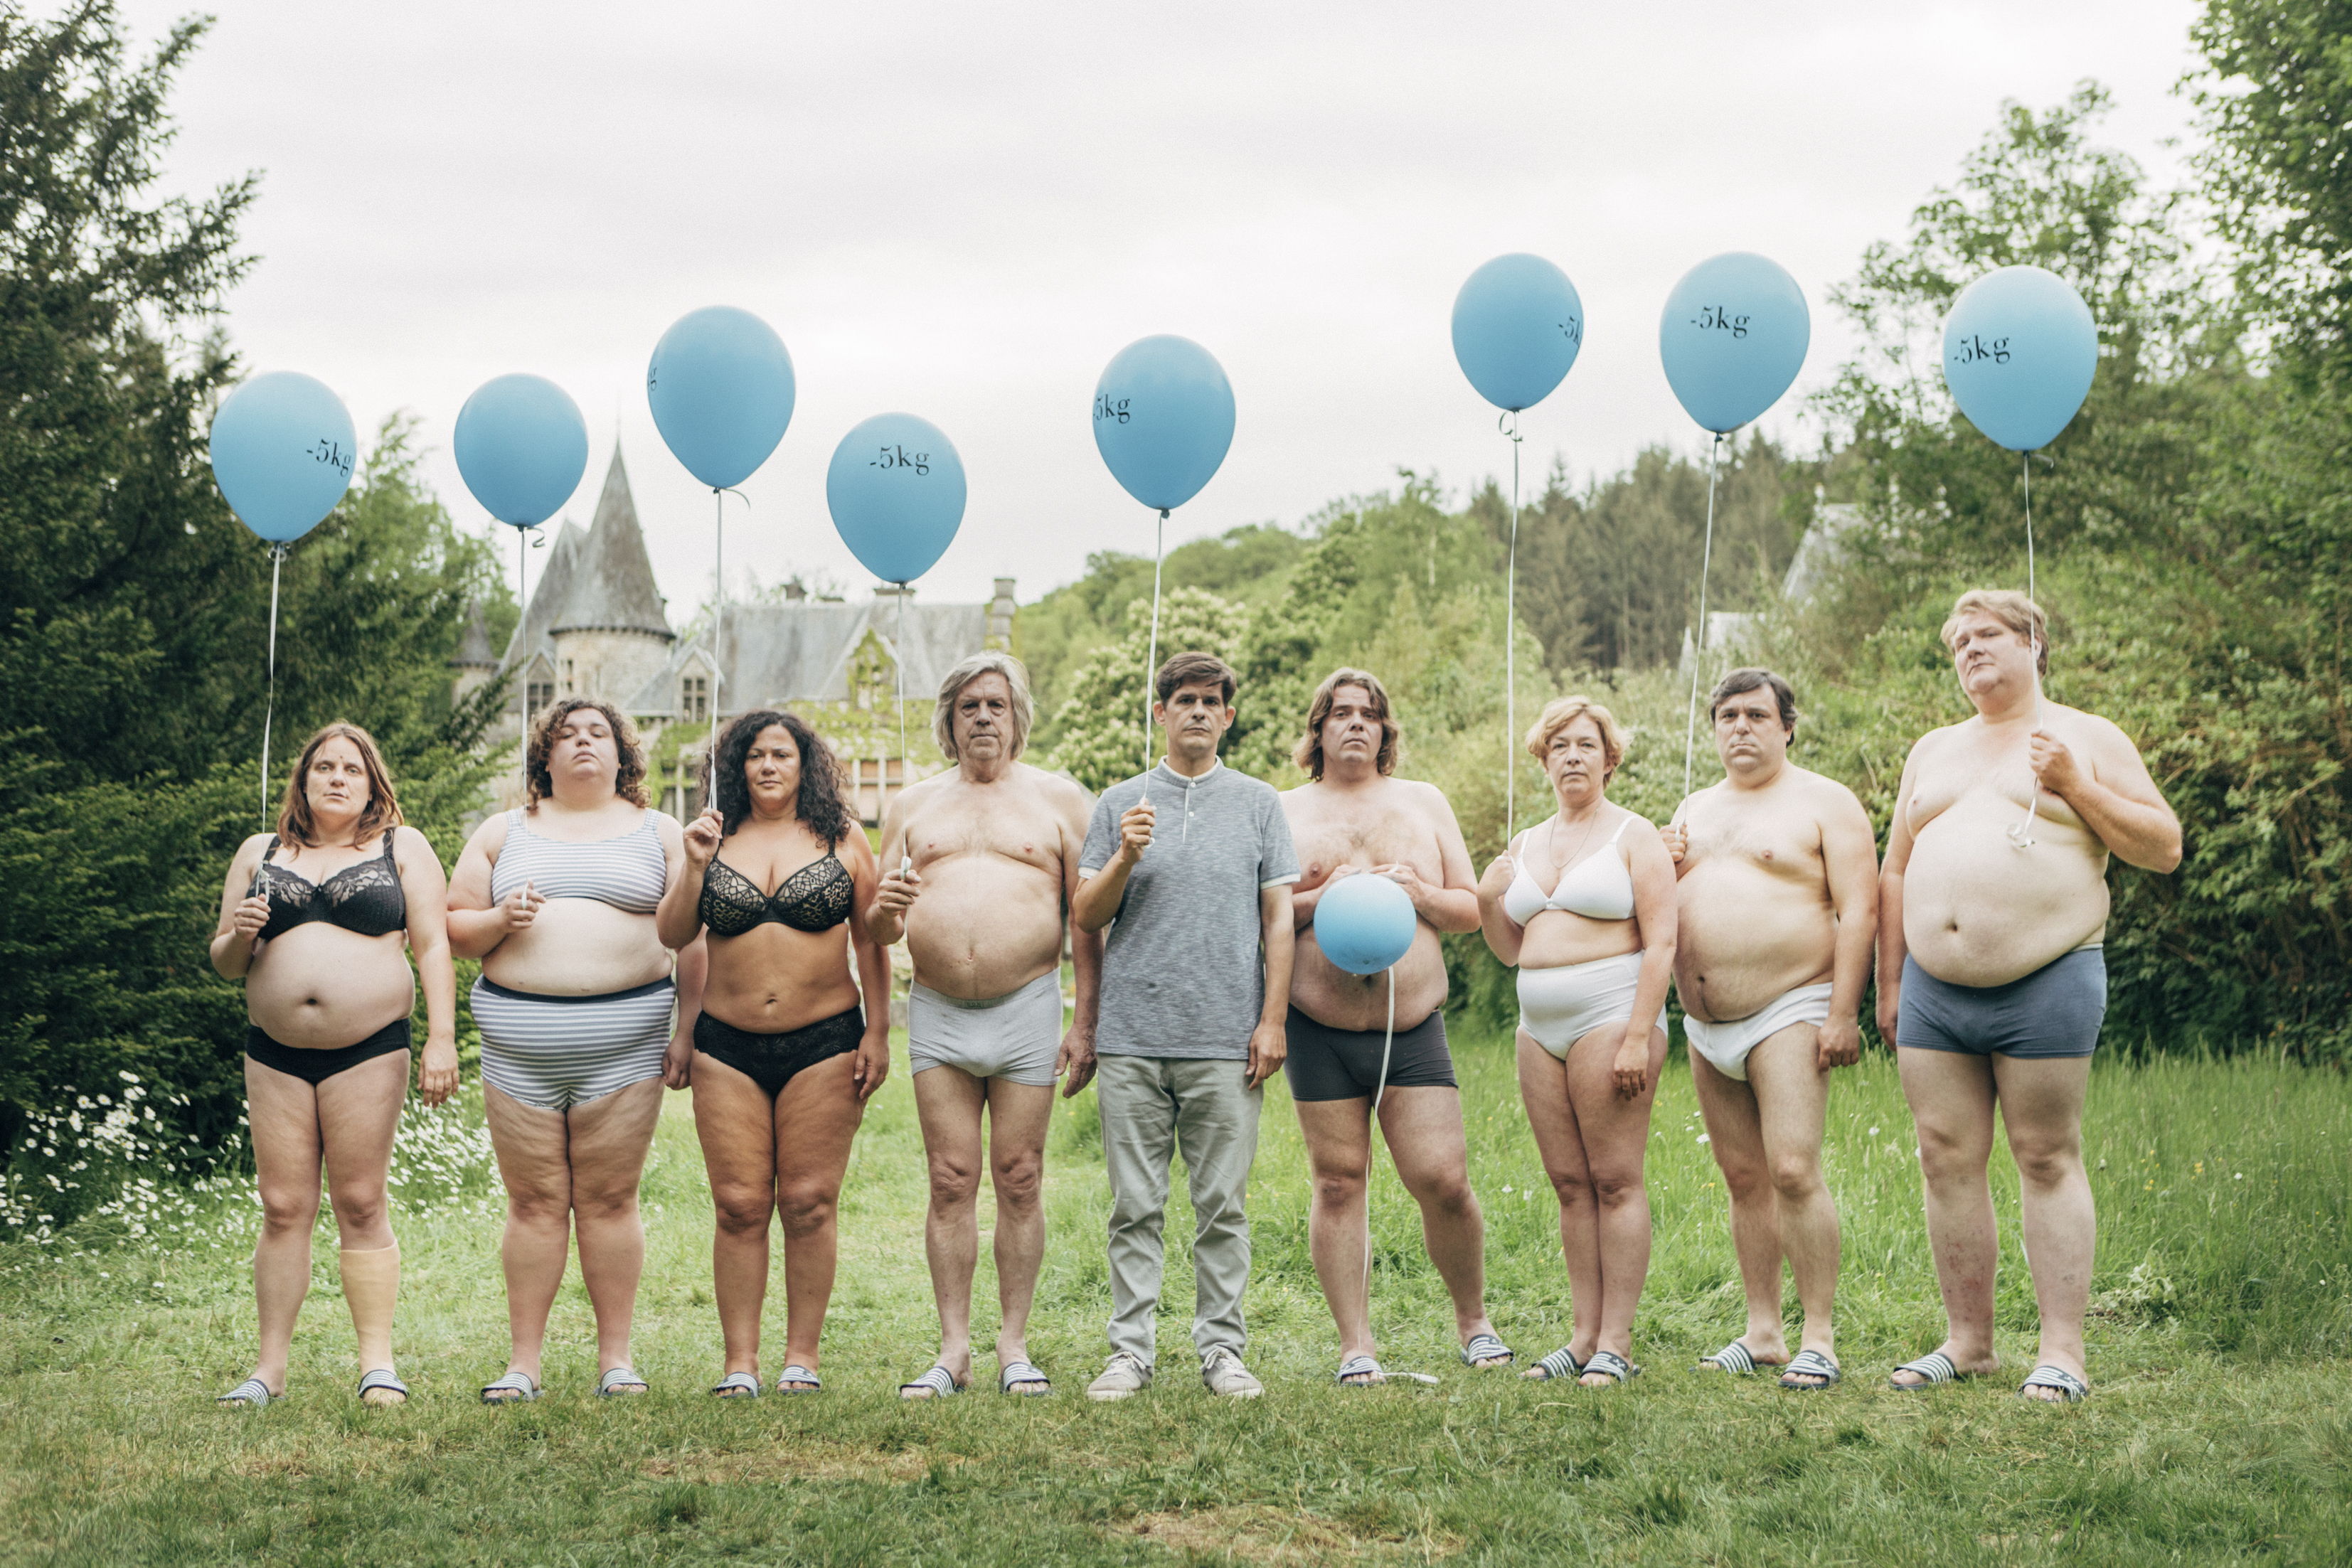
866, 654, 1103, 1399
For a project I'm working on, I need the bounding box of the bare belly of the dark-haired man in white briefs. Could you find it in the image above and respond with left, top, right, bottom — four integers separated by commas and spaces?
1675, 855, 1837, 1023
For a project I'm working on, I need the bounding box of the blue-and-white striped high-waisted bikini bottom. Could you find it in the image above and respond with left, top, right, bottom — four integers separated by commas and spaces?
473, 976, 677, 1109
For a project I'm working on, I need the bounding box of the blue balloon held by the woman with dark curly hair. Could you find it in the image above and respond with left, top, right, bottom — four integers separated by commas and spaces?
644, 306, 792, 489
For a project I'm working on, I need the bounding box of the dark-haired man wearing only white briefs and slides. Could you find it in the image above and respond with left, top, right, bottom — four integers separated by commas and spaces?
1658, 670, 1879, 1390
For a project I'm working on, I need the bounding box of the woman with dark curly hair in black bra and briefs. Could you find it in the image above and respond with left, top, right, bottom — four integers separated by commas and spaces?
656, 713, 889, 1399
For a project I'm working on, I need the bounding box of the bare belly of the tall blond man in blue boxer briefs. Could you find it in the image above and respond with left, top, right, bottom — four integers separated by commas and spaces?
1903, 797, 2107, 985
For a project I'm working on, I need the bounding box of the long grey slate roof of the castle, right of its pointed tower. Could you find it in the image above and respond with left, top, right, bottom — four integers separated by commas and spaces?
628, 592, 988, 715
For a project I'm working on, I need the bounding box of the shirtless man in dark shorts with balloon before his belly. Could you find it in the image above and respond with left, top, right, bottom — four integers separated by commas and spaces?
1282, 668, 1512, 1387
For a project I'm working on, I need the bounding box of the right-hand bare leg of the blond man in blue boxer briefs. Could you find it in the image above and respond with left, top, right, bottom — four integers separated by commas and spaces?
1992, 1055, 2098, 1399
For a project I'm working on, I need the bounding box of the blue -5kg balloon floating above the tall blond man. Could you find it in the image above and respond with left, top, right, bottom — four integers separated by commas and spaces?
1943, 266, 2098, 452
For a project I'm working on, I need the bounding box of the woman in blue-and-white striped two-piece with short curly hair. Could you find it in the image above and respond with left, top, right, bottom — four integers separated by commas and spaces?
449, 698, 694, 1404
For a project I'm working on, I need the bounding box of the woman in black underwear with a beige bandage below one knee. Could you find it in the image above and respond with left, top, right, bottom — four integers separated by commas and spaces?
212, 724, 457, 1411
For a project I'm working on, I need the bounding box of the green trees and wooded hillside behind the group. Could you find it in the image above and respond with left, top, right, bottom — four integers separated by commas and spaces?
0, 0, 2352, 1212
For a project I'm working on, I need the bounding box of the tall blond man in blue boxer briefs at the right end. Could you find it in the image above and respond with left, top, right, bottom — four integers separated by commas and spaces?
1879, 587, 2181, 1401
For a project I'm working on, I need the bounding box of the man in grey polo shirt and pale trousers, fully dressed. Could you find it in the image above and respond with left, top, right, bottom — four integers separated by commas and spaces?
1070, 654, 1298, 1399
